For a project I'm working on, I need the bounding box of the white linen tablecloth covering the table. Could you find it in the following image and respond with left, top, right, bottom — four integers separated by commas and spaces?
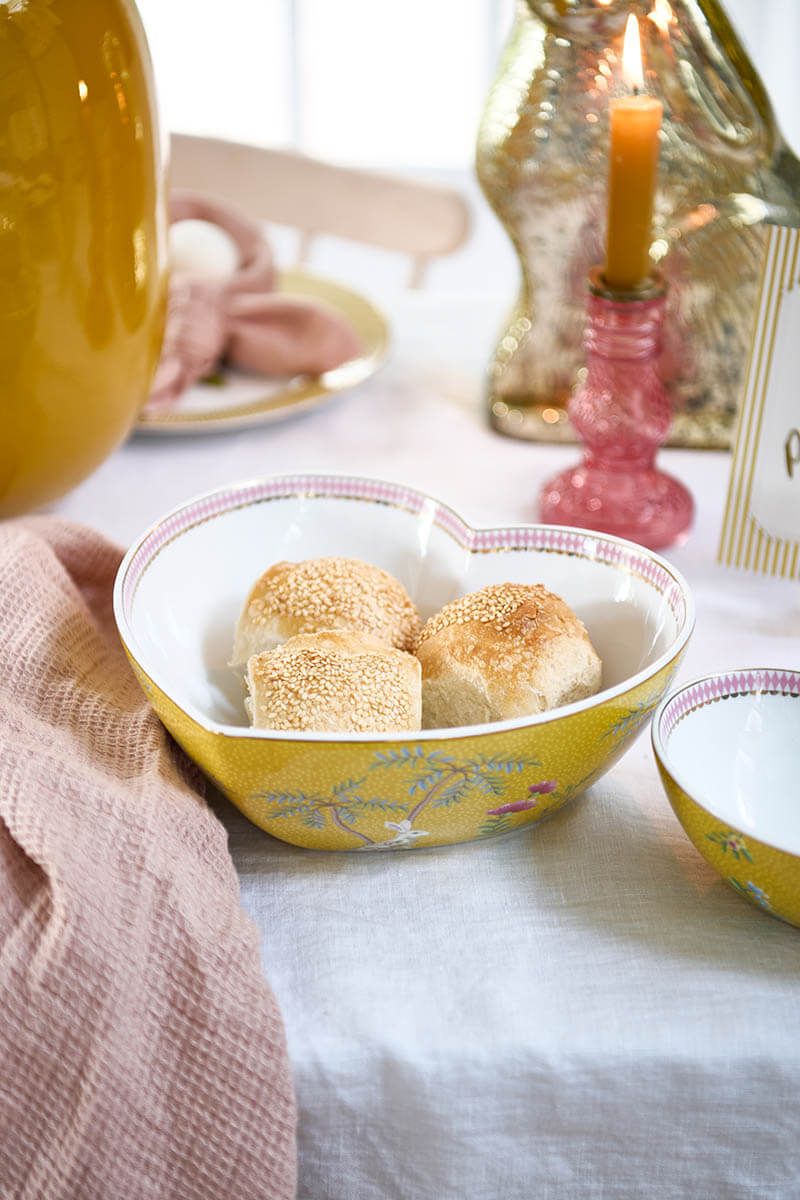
58, 285, 800, 1200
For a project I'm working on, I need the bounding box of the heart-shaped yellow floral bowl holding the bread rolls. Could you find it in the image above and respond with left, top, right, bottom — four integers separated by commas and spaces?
114, 475, 694, 851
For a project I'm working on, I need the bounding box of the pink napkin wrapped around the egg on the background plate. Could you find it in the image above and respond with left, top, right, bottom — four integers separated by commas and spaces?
150, 191, 361, 403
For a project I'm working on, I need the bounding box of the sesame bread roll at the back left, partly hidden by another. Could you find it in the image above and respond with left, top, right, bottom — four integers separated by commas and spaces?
230, 558, 420, 667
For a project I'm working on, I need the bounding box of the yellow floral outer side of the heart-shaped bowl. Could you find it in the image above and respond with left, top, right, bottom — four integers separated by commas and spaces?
128, 652, 679, 851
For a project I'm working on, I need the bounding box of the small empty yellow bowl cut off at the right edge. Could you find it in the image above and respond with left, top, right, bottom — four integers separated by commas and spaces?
652, 670, 800, 925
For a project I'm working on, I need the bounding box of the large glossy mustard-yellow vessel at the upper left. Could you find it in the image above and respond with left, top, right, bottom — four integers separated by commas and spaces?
0, 0, 166, 516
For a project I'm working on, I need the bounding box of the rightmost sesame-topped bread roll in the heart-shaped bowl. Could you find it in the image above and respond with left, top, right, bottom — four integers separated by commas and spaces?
416, 583, 601, 728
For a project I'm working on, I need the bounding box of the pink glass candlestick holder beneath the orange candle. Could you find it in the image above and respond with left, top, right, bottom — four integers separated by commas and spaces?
540, 269, 694, 550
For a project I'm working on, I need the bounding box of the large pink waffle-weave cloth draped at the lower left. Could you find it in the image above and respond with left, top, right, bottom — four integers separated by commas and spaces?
0, 518, 295, 1200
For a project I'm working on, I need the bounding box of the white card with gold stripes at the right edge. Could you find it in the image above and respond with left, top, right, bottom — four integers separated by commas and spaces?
720, 226, 800, 580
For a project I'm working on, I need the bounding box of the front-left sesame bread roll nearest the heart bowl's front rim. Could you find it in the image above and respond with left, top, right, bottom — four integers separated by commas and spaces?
247, 631, 422, 733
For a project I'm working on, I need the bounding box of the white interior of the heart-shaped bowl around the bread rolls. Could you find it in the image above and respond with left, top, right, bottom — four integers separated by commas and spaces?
122, 484, 679, 727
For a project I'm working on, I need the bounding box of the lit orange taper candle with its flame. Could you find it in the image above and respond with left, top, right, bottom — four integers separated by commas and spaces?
606, 13, 663, 292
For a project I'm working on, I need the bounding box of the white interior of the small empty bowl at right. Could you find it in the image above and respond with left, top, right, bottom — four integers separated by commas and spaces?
662, 691, 800, 854
